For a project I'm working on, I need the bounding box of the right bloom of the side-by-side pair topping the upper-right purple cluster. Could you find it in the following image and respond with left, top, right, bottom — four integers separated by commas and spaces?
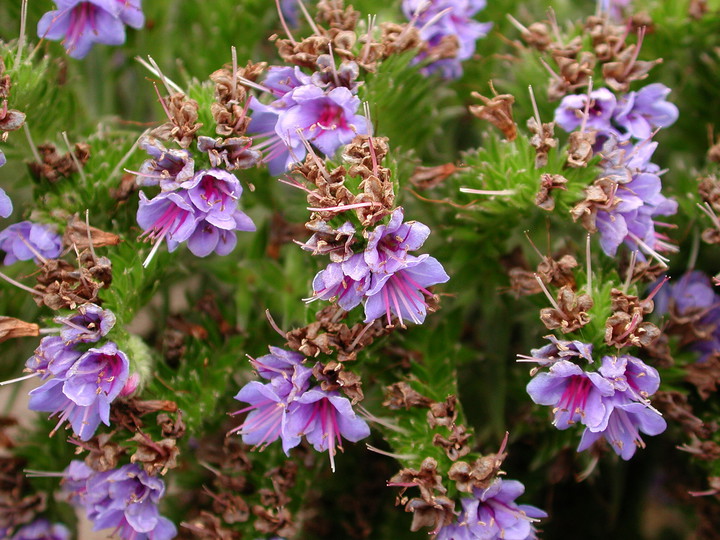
613, 83, 678, 139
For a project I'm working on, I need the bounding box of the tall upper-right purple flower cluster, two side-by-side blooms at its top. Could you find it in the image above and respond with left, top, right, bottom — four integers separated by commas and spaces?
555, 83, 678, 262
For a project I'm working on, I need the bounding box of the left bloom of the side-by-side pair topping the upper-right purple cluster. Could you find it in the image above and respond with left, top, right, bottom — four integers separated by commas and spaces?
555, 88, 617, 134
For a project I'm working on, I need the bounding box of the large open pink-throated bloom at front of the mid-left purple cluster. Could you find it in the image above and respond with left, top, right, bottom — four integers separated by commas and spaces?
29, 342, 130, 441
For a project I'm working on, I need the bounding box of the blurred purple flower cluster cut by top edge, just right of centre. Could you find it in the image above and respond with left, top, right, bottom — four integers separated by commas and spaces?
402, 0, 492, 79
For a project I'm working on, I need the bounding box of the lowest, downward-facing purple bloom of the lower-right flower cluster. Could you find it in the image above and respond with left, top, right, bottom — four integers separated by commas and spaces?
578, 392, 667, 461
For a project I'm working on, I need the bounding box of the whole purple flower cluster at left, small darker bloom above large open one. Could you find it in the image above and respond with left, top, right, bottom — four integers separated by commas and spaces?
26, 304, 137, 441
